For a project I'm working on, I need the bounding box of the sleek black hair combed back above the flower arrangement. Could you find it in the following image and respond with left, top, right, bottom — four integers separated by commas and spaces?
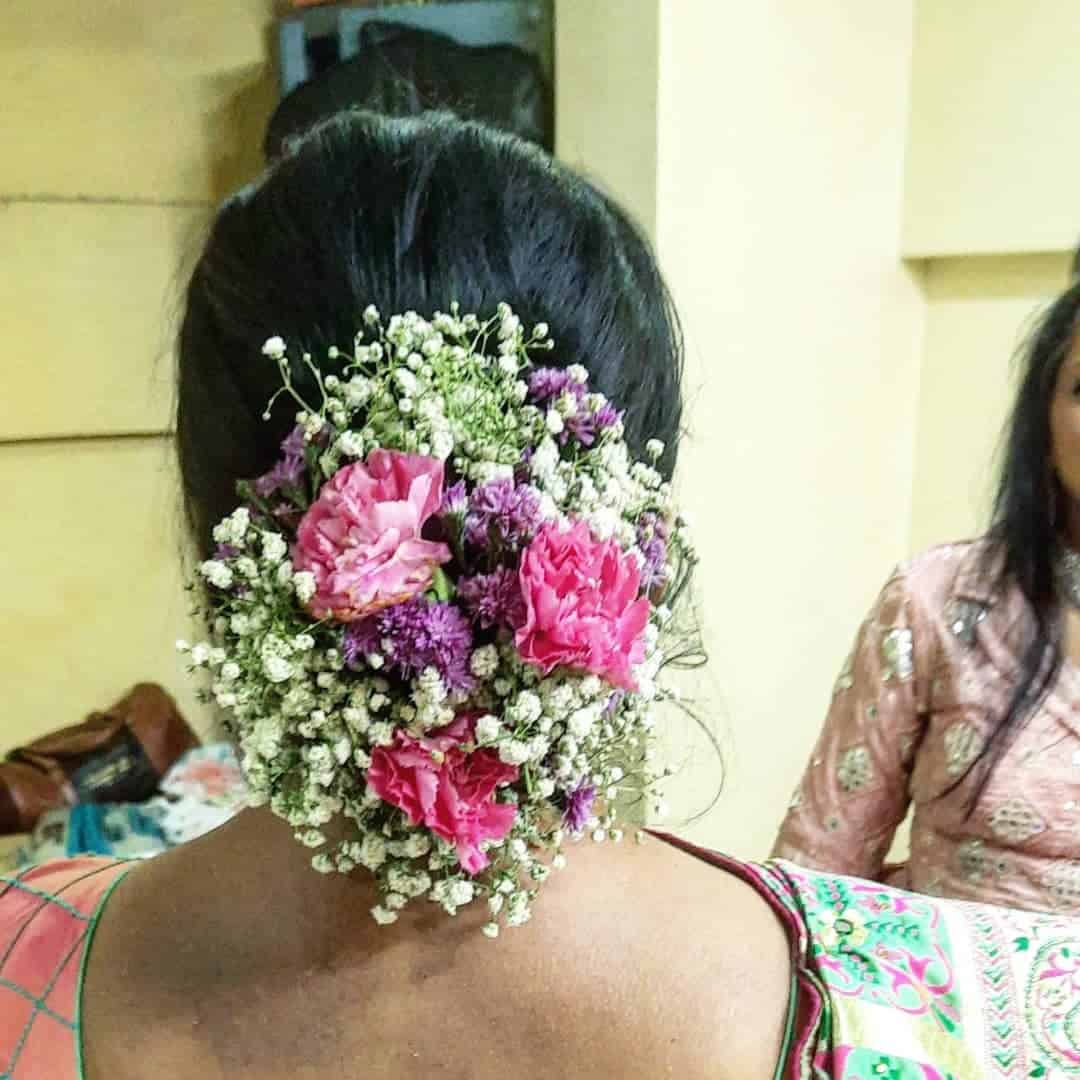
176, 112, 683, 552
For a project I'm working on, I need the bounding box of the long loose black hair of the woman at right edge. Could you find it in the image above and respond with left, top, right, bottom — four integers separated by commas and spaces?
971, 281, 1080, 806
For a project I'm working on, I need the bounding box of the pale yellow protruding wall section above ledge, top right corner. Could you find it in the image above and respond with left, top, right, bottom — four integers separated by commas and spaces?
903, 0, 1080, 257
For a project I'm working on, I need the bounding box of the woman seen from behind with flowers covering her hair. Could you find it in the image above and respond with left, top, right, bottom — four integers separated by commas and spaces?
0, 116, 1080, 1080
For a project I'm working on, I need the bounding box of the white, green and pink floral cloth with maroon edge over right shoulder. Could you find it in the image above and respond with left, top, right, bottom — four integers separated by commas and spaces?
665, 837, 1080, 1080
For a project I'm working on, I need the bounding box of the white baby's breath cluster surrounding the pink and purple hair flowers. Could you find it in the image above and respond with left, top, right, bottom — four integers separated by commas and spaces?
179, 305, 694, 936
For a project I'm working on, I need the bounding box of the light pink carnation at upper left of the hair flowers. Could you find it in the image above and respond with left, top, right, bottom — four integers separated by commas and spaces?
293, 450, 450, 622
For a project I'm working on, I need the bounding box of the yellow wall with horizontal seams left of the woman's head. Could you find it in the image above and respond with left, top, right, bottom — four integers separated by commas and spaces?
0, 0, 275, 751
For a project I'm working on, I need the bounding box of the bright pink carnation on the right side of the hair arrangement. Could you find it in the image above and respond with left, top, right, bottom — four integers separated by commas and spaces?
515, 522, 649, 690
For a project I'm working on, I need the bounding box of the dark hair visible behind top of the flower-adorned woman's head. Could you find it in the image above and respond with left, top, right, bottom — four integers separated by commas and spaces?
264, 22, 553, 161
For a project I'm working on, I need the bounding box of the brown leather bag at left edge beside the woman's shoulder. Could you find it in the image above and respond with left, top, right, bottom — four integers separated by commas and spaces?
0, 683, 199, 835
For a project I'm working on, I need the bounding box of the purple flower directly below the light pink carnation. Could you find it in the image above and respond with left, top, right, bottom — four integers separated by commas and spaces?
341, 596, 474, 690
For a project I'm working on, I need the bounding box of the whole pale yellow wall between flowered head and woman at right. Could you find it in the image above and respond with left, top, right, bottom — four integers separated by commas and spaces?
558, 0, 1080, 855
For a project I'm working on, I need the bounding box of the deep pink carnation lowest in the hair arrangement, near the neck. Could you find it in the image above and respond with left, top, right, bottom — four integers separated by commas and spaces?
367, 715, 517, 874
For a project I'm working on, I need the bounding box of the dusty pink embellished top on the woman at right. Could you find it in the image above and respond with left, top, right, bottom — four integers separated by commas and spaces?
774, 541, 1080, 914
